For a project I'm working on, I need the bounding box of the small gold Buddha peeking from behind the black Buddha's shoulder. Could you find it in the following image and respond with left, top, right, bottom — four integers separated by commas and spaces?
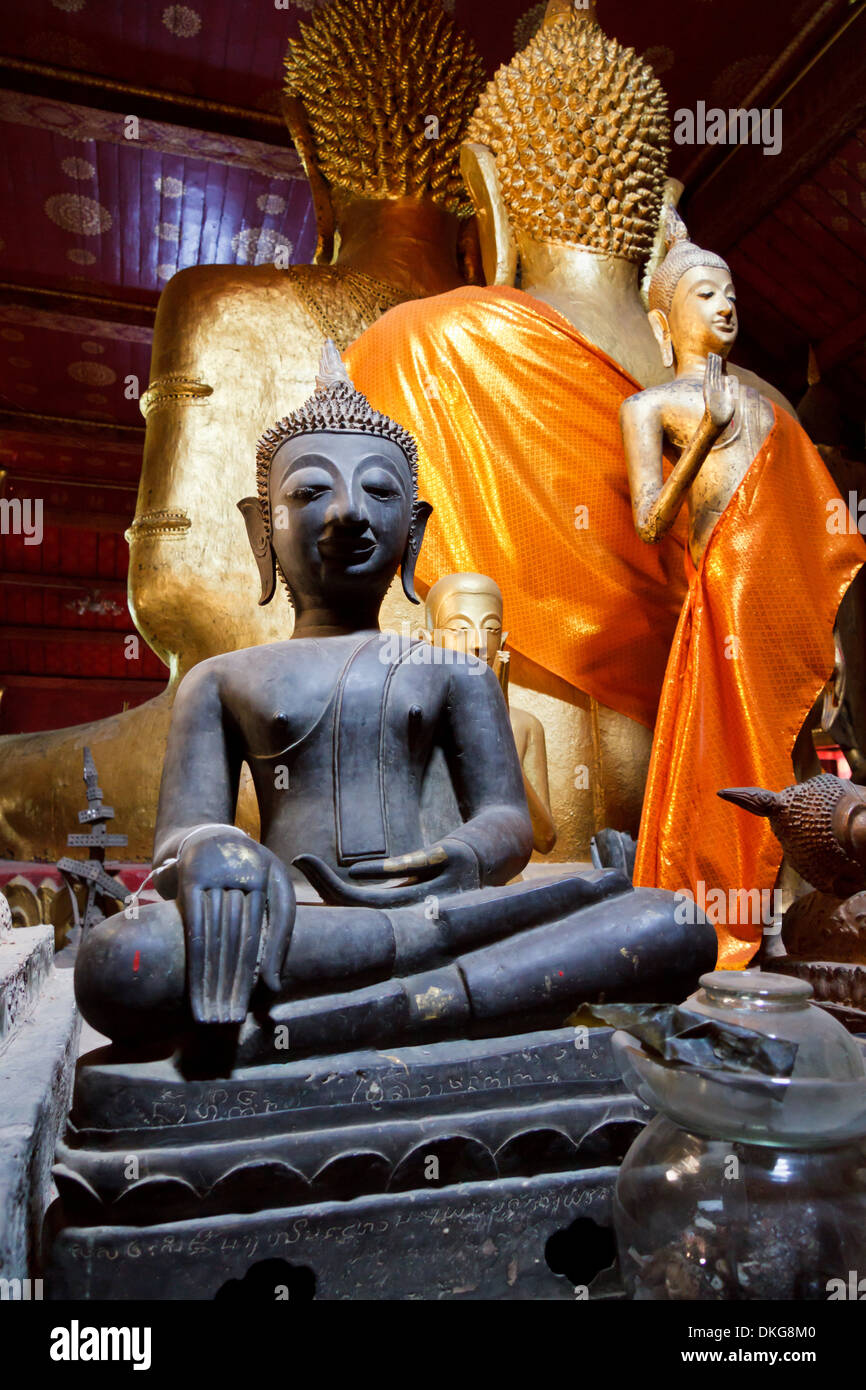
423, 574, 556, 855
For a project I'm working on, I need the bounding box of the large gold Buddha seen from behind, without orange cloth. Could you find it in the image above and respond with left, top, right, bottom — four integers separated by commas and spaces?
0, 0, 484, 859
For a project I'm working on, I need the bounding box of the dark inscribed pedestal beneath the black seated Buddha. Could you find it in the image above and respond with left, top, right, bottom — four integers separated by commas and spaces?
49, 1029, 648, 1301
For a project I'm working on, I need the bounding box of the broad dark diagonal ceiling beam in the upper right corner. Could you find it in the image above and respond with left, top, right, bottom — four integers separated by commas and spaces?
683, 0, 866, 254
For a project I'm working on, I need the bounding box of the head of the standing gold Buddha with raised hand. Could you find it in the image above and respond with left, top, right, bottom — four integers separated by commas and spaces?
649, 207, 738, 367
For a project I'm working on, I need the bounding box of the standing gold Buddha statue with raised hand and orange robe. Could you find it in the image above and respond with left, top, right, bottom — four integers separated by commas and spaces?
621, 213, 866, 969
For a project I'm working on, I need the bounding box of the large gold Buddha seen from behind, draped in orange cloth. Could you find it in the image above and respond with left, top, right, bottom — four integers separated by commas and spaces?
348, 0, 800, 860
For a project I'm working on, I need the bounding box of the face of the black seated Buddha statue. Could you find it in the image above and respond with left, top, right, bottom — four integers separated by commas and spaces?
270, 432, 413, 600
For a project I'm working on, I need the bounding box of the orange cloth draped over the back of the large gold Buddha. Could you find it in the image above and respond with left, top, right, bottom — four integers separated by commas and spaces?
346, 286, 685, 727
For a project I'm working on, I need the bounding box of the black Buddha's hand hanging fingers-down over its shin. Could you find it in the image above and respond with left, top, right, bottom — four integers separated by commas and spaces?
178, 833, 295, 1023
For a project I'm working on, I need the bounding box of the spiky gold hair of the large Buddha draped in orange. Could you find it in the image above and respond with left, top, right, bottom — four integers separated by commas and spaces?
467, 13, 670, 261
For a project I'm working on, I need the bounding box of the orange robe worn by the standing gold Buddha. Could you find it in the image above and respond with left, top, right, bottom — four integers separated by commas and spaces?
634, 410, 866, 970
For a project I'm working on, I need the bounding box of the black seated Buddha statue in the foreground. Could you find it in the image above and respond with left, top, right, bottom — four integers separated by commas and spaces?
75, 345, 716, 1059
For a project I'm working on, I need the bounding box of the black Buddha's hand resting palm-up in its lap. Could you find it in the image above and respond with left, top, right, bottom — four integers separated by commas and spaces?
293, 837, 481, 908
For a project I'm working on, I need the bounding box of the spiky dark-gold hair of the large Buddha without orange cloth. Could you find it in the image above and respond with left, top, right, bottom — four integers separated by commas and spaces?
285, 0, 484, 215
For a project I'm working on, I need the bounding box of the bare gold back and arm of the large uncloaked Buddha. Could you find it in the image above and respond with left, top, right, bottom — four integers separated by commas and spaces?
128, 265, 414, 673
